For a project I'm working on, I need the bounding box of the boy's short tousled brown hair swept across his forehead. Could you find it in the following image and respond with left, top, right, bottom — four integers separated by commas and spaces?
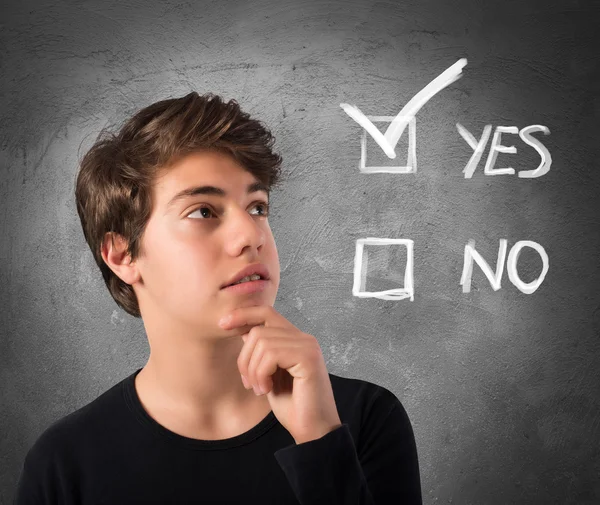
75, 91, 282, 318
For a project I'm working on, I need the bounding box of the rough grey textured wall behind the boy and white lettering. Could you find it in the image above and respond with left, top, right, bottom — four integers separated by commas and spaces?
0, 0, 600, 505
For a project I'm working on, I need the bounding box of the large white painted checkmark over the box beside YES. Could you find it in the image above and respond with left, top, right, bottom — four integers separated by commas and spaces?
340, 58, 467, 159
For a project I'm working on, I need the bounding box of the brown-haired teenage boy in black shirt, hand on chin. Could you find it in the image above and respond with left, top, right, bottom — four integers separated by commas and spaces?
14, 92, 422, 505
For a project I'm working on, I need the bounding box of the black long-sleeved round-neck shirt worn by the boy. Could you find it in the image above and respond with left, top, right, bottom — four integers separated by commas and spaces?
13, 368, 422, 505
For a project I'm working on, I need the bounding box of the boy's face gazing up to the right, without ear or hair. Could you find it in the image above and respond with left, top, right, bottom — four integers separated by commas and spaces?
133, 151, 279, 336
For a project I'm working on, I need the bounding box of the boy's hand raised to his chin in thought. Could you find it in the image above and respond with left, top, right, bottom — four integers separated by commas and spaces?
219, 305, 342, 444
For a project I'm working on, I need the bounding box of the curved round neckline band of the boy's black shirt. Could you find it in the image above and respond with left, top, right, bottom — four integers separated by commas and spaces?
122, 368, 278, 450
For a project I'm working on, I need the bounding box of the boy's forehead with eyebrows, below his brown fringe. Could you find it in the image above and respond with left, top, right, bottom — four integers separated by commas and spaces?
153, 151, 268, 210
